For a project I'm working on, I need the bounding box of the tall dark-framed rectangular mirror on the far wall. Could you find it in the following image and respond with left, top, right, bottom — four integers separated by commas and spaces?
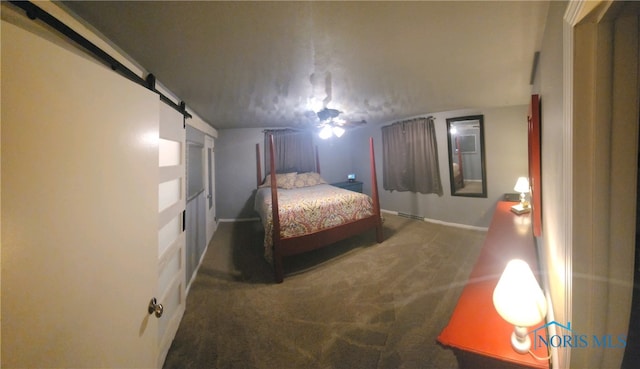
447, 115, 487, 197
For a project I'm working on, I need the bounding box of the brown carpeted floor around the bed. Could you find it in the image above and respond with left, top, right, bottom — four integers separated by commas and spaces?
164, 214, 485, 369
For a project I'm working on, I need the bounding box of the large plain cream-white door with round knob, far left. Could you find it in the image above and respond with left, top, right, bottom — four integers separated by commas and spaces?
1, 21, 159, 368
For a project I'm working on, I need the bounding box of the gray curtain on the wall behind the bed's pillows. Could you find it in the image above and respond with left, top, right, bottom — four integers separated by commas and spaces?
264, 129, 316, 175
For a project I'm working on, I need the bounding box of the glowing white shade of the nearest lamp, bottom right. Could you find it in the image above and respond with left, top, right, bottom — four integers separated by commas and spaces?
493, 259, 547, 327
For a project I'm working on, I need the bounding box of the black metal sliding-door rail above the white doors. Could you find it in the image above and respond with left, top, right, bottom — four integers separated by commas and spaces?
10, 1, 192, 118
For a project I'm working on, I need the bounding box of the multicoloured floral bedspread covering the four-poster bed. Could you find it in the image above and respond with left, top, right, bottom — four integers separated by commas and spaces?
254, 184, 373, 261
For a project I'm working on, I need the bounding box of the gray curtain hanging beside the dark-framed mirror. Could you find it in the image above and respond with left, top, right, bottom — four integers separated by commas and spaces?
382, 118, 443, 196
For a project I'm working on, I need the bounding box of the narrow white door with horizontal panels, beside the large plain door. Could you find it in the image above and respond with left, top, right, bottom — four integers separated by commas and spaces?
157, 103, 186, 367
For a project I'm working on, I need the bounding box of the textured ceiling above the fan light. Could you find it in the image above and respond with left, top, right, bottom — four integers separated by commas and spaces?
64, 1, 548, 129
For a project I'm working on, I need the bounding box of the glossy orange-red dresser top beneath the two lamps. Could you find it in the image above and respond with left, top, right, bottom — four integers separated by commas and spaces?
438, 201, 549, 368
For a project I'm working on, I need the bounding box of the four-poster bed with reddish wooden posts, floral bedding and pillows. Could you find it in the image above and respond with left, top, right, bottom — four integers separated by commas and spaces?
254, 136, 383, 283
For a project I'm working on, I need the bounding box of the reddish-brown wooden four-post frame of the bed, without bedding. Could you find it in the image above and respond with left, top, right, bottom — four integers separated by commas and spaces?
256, 136, 383, 283
